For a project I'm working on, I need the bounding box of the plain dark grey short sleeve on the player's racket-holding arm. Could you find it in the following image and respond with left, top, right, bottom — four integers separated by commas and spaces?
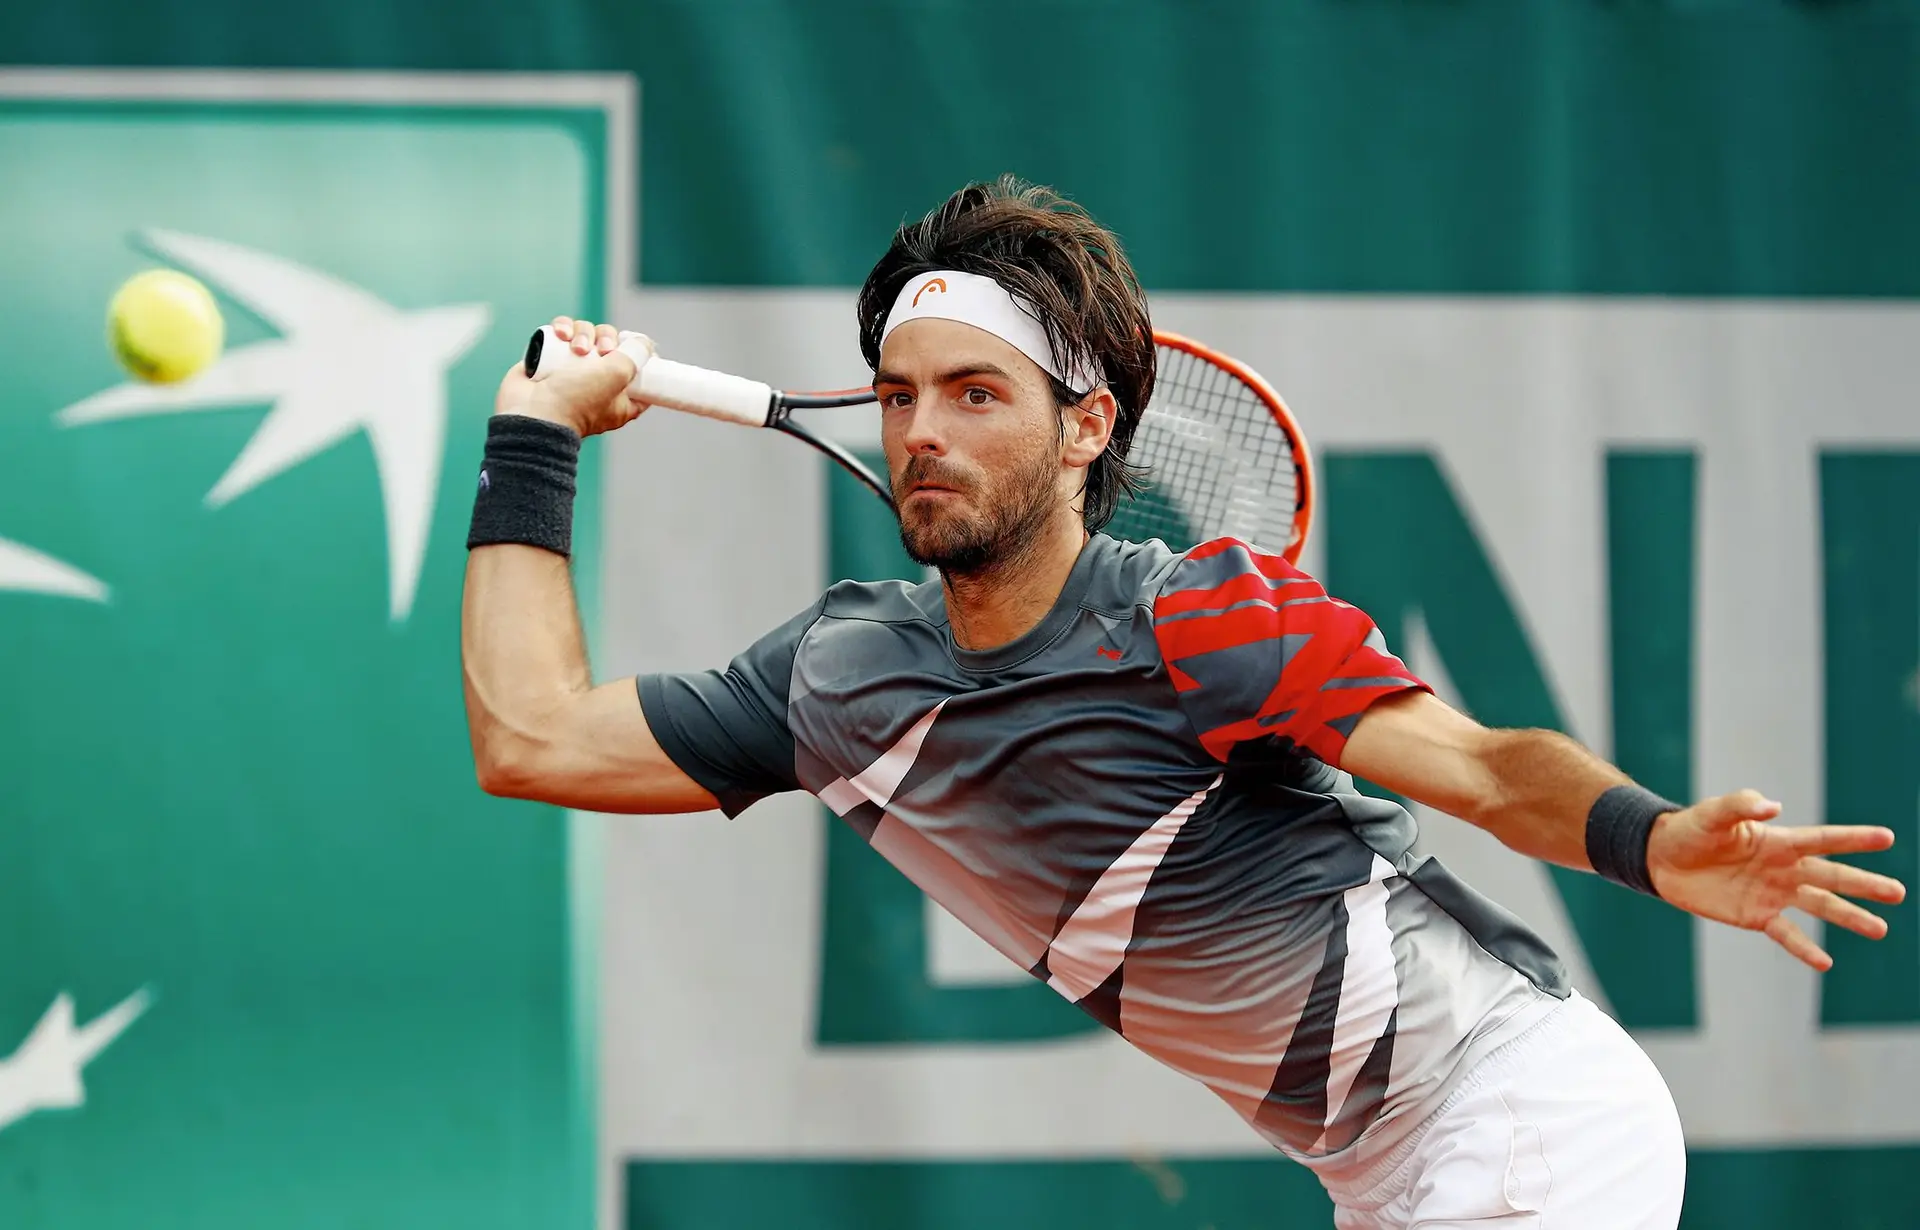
637, 599, 826, 817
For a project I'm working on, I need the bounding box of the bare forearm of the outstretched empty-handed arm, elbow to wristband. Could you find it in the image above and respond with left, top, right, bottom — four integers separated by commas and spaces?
1461, 729, 1630, 871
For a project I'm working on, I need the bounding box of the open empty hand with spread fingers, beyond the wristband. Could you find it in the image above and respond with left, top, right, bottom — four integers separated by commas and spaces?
1647, 791, 1907, 971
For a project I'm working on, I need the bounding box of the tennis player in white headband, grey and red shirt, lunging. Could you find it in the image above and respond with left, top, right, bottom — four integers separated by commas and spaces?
463, 180, 1903, 1230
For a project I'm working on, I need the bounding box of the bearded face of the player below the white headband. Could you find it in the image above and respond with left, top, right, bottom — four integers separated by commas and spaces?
874, 320, 1069, 574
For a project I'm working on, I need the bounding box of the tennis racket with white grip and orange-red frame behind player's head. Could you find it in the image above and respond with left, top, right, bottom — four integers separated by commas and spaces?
526, 326, 1315, 562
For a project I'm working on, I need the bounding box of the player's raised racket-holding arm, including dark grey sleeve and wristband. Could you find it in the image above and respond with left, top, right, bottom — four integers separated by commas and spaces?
461, 317, 826, 816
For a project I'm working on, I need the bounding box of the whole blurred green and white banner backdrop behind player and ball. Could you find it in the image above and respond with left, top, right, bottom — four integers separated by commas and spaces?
0, 0, 1920, 1230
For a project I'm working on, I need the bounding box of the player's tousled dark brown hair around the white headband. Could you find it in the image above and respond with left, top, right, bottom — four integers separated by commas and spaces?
856, 175, 1154, 530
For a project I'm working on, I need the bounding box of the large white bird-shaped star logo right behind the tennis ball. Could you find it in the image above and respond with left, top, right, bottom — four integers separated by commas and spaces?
58, 230, 492, 620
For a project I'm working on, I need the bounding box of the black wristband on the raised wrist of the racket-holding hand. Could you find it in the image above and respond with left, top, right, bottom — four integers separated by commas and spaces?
467, 414, 580, 555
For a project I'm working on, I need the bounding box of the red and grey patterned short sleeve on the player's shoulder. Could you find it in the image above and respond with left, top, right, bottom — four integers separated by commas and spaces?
1154, 537, 1430, 768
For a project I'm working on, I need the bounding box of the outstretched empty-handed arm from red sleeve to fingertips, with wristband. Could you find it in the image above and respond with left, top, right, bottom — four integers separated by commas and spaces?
1338, 691, 1907, 971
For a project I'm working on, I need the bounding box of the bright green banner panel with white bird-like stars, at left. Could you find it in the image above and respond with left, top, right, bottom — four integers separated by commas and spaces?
0, 88, 605, 1230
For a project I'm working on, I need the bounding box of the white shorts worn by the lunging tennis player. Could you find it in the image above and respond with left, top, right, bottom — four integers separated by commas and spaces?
1327, 994, 1686, 1230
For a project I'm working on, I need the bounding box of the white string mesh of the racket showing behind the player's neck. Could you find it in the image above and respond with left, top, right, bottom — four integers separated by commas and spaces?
1106, 345, 1300, 551
